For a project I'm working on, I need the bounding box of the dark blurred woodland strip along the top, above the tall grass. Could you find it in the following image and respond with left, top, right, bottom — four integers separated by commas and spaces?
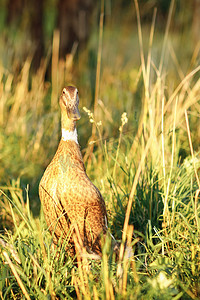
0, 0, 200, 70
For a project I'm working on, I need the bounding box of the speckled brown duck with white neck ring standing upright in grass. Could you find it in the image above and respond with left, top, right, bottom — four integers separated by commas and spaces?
39, 86, 107, 256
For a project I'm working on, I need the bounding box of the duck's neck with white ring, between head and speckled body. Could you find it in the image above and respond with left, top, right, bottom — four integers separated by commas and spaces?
61, 114, 78, 144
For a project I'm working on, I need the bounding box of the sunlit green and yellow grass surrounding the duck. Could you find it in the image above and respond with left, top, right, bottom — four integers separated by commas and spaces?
0, 1, 200, 299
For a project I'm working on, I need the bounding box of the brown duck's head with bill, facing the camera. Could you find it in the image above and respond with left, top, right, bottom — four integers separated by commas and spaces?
59, 86, 81, 121
